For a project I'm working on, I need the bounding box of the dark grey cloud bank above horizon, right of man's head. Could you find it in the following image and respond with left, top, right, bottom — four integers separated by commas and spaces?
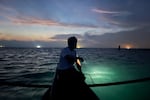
82, 28, 150, 48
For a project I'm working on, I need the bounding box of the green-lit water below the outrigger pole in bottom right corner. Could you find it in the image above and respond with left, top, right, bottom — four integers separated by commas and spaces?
92, 81, 150, 100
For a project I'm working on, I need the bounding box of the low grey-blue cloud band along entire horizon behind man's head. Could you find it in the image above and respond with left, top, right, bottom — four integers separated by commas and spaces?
0, 28, 150, 48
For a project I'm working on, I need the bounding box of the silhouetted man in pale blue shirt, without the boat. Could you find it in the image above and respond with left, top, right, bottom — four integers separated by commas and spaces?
57, 36, 83, 78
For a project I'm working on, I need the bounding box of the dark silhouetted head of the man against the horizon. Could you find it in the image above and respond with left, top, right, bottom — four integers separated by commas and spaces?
68, 36, 77, 49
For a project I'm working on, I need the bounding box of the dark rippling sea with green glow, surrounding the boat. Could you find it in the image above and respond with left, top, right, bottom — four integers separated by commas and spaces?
0, 48, 150, 100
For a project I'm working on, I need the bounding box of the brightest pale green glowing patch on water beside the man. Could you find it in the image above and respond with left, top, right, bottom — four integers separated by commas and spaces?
83, 65, 117, 84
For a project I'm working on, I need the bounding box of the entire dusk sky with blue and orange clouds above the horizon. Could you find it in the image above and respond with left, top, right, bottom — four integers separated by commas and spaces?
0, 0, 150, 48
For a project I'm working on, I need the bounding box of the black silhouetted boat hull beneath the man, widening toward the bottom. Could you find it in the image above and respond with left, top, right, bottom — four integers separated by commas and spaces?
42, 69, 100, 100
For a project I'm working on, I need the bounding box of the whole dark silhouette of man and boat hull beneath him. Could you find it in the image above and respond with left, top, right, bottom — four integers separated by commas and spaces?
42, 36, 99, 100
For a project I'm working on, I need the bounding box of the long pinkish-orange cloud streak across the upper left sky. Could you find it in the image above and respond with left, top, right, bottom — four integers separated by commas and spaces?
3, 16, 98, 28
